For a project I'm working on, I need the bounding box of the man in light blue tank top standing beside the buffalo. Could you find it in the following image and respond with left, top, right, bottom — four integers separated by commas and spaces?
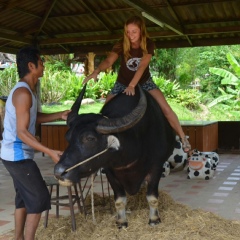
1, 46, 69, 240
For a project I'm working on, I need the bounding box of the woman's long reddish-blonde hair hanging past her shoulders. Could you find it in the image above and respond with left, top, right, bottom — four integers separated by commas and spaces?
123, 16, 148, 62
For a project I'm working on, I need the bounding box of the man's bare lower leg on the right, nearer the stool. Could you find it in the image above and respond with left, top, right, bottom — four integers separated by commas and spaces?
24, 213, 41, 240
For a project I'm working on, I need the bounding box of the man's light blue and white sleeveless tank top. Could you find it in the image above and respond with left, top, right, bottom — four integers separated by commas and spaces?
1, 82, 37, 161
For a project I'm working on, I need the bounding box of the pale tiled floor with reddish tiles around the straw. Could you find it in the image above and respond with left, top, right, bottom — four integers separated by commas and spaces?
0, 153, 240, 236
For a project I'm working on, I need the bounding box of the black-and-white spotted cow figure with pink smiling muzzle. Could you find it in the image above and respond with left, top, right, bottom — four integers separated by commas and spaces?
187, 151, 215, 180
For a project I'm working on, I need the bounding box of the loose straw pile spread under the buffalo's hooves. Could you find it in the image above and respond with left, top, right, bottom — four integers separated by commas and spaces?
33, 189, 240, 240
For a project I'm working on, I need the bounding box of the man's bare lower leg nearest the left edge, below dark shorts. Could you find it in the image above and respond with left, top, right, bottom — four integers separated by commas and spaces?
15, 208, 27, 240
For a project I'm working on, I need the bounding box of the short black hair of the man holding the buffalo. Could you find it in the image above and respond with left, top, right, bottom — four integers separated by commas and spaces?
17, 46, 40, 78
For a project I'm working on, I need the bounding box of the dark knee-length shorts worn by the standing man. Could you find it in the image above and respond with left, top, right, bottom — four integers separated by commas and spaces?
2, 159, 51, 213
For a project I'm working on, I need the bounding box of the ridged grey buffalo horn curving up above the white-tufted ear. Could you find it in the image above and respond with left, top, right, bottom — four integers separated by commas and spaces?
96, 86, 147, 134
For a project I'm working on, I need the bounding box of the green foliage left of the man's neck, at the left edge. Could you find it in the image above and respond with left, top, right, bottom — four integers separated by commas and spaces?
0, 66, 19, 96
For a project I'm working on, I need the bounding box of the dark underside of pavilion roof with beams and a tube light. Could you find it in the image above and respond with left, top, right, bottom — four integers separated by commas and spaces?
0, 0, 240, 55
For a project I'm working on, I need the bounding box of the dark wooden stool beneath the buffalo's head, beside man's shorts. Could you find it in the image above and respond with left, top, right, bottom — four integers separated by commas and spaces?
43, 176, 85, 231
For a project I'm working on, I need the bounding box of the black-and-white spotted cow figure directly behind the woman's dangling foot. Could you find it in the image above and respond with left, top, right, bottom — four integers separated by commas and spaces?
168, 136, 188, 171
